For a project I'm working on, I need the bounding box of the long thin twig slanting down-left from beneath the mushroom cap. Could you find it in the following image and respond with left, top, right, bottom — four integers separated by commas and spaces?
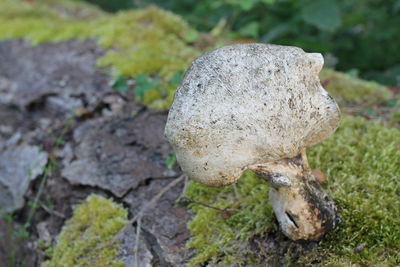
95, 174, 186, 250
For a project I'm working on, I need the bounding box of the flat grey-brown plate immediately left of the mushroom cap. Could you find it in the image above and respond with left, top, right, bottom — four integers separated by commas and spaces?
62, 106, 171, 197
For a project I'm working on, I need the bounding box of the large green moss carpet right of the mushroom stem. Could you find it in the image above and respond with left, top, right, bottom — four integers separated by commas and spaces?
304, 117, 400, 266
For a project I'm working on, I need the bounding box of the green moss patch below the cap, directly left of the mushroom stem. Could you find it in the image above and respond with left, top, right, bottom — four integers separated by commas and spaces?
186, 172, 275, 266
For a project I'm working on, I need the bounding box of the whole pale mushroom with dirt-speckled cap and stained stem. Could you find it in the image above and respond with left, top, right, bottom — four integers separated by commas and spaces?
165, 44, 340, 240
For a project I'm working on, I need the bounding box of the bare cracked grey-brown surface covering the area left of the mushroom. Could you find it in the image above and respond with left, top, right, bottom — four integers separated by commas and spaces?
0, 40, 189, 267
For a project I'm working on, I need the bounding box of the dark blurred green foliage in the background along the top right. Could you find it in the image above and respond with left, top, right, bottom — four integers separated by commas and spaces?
88, 0, 400, 85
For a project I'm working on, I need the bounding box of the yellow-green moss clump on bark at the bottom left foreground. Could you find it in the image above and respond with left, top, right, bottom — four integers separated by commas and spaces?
42, 195, 127, 267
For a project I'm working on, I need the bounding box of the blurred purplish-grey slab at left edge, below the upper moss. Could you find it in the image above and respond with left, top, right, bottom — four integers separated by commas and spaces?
0, 40, 110, 113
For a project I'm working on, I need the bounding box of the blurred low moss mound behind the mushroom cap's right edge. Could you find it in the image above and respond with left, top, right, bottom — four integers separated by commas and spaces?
320, 69, 393, 106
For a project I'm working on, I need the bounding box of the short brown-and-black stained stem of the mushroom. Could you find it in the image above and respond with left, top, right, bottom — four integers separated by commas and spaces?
248, 152, 340, 240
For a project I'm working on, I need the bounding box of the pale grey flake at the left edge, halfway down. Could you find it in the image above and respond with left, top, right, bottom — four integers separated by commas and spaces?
0, 134, 47, 215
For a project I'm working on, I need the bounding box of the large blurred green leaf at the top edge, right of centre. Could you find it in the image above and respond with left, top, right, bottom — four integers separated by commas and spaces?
302, 0, 341, 32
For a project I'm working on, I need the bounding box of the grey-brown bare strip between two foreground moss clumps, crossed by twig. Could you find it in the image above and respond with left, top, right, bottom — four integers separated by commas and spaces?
124, 179, 190, 266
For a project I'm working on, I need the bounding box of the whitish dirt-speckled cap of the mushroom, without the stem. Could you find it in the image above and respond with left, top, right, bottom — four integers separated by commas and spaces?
165, 44, 340, 186
